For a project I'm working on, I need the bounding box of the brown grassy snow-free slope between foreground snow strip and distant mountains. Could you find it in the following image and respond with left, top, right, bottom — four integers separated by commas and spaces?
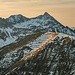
0, 32, 45, 57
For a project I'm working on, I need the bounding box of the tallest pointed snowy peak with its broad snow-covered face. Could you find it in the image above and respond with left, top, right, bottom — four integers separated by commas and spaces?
13, 12, 75, 36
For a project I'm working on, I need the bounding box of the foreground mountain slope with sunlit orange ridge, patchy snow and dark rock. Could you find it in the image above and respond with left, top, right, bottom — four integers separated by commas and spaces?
0, 33, 75, 75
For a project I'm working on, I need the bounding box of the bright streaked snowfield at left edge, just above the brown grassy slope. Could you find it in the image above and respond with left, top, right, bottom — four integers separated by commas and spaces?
0, 27, 18, 47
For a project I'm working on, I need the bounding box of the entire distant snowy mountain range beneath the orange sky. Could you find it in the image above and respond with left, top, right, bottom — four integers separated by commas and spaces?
0, 12, 75, 47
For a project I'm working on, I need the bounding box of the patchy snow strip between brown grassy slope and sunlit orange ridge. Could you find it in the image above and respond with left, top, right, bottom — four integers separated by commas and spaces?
0, 33, 48, 68
